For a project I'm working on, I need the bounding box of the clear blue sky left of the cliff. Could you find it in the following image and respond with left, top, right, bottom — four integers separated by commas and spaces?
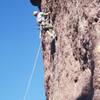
0, 0, 45, 100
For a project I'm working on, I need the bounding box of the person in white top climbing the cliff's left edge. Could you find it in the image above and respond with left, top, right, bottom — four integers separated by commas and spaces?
33, 11, 55, 38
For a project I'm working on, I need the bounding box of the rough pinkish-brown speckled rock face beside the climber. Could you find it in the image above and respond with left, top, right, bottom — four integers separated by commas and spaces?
42, 0, 100, 100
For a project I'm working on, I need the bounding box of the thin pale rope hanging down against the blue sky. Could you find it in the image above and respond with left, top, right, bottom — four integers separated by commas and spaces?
23, 43, 41, 100
